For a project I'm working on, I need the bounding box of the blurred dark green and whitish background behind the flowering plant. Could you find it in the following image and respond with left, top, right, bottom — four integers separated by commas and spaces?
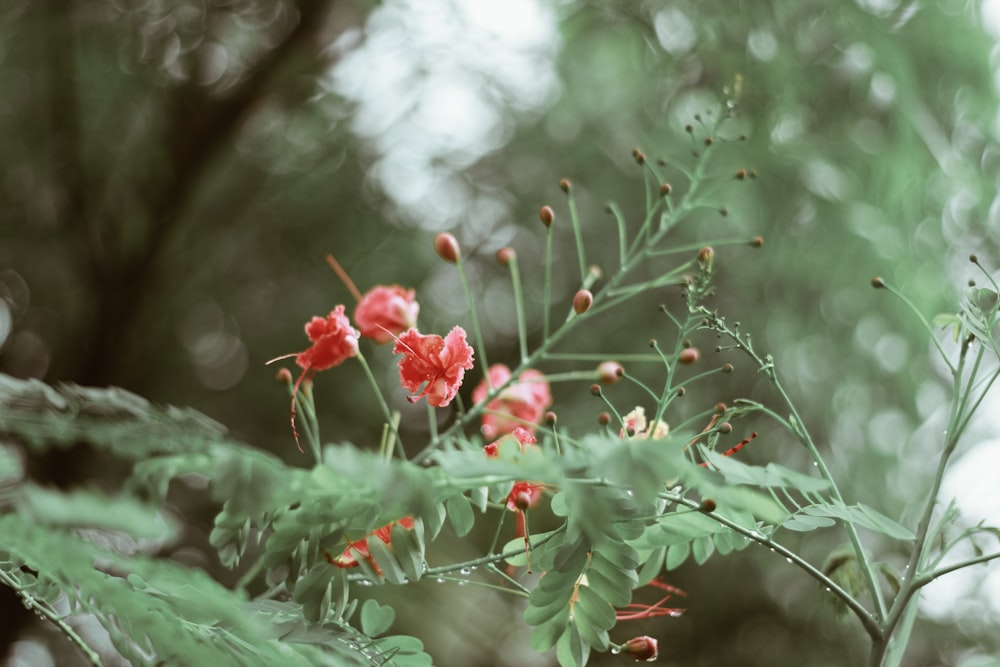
0, 0, 1000, 667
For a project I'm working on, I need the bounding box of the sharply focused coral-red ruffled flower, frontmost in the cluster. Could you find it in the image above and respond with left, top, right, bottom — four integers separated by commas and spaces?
392, 327, 473, 408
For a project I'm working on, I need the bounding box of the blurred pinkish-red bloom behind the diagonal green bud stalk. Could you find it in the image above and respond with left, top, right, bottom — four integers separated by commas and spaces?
472, 364, 552, 438
